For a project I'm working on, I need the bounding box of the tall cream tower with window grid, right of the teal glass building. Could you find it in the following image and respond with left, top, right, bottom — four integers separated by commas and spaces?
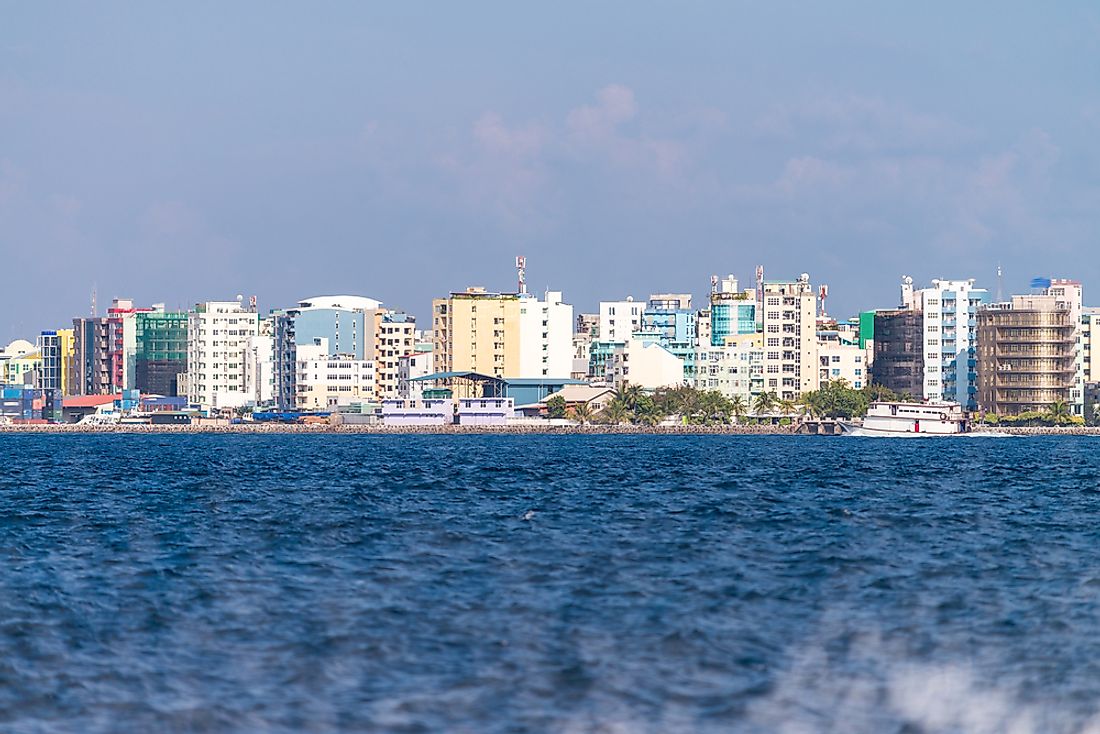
758, 273, 818, 401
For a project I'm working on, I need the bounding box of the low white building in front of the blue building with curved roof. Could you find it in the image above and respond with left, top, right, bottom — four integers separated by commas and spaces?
295, 338, 377, 410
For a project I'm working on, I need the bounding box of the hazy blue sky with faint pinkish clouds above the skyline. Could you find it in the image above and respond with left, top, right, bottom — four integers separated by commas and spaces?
0, 0, 1100, 341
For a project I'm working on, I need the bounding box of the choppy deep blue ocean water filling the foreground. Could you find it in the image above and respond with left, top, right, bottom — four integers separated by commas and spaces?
0, 435, 1100, 734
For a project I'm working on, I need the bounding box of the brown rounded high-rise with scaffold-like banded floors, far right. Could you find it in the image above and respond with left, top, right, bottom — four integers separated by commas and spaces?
978, 295, 1078, 415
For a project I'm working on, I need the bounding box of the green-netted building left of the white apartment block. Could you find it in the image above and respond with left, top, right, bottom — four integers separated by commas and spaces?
133, 311, 187, 397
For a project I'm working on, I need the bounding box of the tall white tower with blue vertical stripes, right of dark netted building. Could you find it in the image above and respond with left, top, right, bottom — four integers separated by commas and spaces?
902, 277, 989, 410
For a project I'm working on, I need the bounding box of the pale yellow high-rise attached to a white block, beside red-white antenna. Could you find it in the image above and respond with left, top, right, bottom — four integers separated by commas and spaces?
431, 287, 520, 377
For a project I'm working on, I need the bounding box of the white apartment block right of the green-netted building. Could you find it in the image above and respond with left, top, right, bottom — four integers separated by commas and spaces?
187, 300, 260, 409
